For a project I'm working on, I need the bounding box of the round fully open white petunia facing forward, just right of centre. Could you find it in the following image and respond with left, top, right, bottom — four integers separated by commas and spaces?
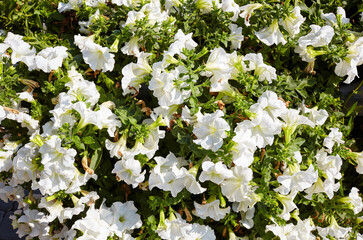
193, 110, 230, 152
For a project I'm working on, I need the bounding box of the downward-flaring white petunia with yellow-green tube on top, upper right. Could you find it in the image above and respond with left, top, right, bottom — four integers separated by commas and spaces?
255, 19, 286, 46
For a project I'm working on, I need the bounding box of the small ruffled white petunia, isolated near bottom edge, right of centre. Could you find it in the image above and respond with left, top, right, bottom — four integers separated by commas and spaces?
193, 199, 231, 221
